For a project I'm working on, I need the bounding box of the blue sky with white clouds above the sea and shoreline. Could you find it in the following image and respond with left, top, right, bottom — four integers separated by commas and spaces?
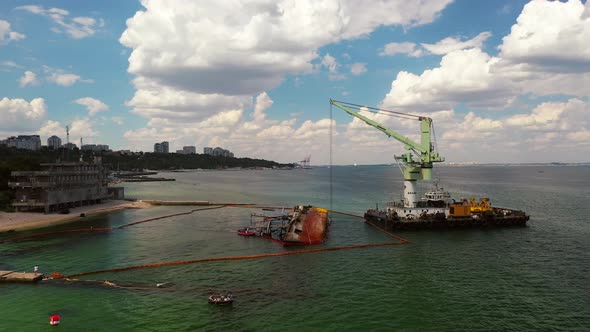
0, 0, 590, 165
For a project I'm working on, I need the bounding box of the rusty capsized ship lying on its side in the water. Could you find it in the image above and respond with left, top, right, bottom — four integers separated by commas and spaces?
248, 205, 330, 245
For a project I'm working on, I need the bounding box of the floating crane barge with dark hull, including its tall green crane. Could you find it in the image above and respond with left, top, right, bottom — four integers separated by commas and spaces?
330, 99, 529, 229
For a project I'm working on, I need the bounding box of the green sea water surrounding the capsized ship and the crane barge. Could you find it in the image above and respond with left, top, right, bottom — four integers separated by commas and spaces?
0, 166, 590, 331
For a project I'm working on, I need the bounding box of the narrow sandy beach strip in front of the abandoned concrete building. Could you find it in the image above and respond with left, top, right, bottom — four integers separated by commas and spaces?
0, 200, 150, 233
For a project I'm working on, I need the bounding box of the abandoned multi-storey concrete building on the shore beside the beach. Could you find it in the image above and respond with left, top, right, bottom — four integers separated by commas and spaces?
8, 159, 123, 213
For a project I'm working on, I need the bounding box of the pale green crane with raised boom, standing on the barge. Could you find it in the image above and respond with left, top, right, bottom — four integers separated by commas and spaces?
330, 99, 445, 207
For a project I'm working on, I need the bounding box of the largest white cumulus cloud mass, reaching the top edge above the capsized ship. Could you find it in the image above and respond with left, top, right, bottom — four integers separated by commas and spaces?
120, 0, 451, 160
